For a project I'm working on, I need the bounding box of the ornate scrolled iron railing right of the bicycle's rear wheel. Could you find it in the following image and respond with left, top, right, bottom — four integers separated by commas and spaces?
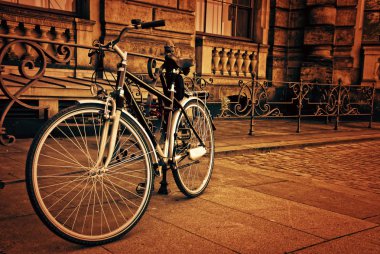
216, 77, 376, 135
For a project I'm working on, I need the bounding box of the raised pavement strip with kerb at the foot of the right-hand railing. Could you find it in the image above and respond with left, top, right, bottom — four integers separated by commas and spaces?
215, 119, 380, 155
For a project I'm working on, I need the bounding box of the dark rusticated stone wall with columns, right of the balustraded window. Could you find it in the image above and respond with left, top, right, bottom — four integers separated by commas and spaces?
267, 0, 380, 84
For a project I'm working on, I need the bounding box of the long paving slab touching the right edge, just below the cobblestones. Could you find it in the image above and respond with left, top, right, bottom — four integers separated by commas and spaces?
249, 181, 380, 219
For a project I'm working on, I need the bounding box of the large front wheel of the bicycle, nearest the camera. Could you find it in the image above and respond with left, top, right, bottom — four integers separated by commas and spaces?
26, 104, 153, 245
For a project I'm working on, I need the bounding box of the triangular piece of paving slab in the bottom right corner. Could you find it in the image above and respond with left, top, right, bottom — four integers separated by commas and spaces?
294, 227, 380, 254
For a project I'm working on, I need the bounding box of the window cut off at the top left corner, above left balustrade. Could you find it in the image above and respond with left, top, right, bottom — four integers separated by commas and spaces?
2, 0, 76, 12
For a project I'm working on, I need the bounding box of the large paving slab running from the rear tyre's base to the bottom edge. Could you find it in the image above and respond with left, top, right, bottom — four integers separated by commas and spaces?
148, 190, 322, 253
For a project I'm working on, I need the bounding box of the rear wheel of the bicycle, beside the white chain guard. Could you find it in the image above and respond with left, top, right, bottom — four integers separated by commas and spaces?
173, 99, 215, 197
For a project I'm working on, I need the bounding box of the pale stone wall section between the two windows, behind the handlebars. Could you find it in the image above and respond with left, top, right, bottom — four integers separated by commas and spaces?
102, 0, 195, 73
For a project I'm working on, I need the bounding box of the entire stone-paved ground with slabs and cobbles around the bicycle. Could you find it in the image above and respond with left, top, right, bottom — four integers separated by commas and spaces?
0, 120, 380, 253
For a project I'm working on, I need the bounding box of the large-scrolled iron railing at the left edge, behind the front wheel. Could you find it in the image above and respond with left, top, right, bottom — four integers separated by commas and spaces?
0, 34, 163, 145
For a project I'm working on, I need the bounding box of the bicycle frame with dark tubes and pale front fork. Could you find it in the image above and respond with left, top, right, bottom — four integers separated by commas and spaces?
97, 45, 204, 170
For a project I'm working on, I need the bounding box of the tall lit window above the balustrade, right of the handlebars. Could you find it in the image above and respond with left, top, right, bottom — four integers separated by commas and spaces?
195, 0, 253, 38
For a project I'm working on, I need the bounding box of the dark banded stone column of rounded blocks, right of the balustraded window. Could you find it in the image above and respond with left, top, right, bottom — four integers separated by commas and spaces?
301, 0, 337, 83
